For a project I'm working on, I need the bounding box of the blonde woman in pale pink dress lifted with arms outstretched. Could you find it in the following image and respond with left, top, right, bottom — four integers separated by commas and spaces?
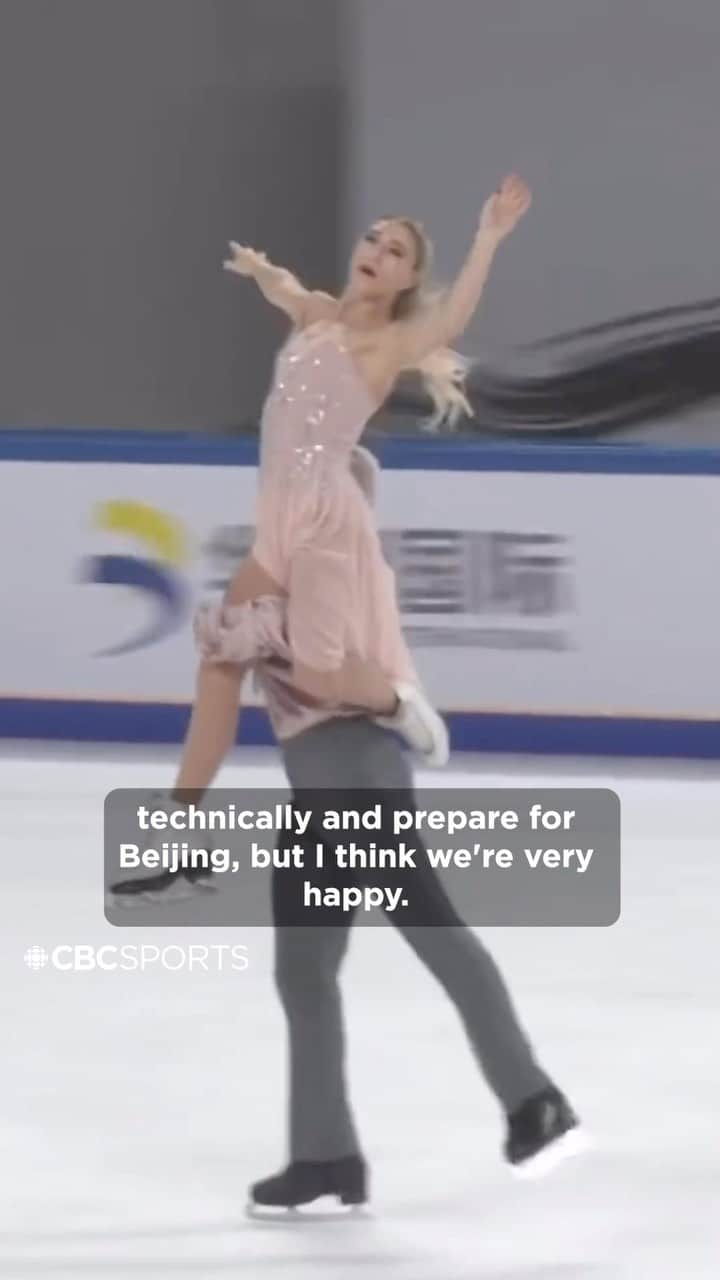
173, 177, 530, 803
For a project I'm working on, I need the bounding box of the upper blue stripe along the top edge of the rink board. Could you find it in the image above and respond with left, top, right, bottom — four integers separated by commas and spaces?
0, 428, 720, 476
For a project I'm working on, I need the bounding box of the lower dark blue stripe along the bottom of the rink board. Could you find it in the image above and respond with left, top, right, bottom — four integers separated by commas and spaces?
0, 698, 720, 760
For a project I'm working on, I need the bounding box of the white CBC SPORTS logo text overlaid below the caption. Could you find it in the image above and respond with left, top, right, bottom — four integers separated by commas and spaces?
23, 942, 249, 973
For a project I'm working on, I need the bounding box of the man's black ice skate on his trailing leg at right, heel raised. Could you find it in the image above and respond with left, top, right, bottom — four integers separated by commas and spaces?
505, 1087, 587, 1178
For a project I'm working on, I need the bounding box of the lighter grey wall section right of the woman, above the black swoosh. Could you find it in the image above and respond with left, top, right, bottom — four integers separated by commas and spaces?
345, 0, 720, 438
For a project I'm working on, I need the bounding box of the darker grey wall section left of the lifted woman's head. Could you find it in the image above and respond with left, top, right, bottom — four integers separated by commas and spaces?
0, 0, 345, 429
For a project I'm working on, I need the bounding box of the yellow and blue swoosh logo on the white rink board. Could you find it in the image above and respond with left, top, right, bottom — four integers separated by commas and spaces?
82, 500, 190, 658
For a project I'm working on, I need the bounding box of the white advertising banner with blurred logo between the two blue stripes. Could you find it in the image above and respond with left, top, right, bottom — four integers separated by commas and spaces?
0, 461, 720, 718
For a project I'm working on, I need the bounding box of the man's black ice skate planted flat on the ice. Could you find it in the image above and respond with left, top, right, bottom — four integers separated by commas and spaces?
247, 1156, 368, 1217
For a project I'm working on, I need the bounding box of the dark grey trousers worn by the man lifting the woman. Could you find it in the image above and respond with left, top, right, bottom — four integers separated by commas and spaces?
273, 718, 551, 1160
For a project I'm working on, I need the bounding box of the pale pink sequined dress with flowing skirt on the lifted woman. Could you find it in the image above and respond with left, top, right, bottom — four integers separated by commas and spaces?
252, 326, 418, 684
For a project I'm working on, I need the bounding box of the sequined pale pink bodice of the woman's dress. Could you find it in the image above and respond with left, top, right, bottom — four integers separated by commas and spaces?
260, 333, 375, 483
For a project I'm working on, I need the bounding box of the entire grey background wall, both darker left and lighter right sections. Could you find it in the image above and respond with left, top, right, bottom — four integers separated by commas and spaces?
7, 0, 720, 439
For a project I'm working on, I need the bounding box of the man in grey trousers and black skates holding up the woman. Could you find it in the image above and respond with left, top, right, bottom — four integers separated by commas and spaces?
243, 586, 579, 1207
